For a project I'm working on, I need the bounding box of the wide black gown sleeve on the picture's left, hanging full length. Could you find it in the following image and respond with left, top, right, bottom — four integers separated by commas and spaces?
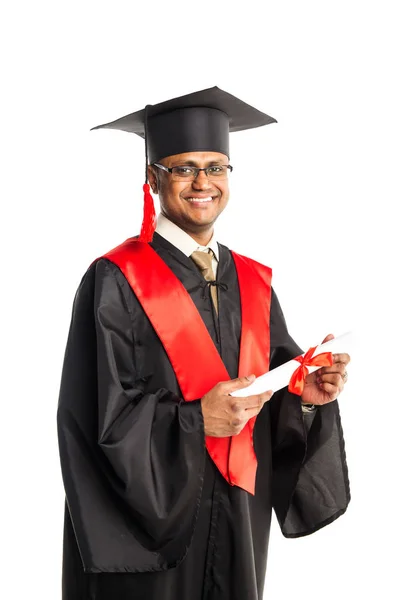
57, 259, 205, 572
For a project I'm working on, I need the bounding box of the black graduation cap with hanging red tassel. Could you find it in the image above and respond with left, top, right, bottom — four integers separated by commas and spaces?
92, 87, 276, 242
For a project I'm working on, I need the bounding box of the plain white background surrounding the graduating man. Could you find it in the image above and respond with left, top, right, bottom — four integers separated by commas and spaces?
0, 0, 400, 600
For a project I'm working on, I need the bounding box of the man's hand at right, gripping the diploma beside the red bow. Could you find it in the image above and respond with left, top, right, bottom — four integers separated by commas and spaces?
301, 334, 350, 405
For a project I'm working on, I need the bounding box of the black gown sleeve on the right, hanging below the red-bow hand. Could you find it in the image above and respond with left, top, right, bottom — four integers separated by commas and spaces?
269, 291, 350, 537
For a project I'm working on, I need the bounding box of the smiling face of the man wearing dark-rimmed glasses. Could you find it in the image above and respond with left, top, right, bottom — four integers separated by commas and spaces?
149, 152, 229, 237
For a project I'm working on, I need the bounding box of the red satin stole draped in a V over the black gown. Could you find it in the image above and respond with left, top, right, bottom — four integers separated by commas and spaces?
104, 238, 271, 494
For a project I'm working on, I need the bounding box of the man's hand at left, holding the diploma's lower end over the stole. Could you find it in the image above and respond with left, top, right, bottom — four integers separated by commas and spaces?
201, 375, 273, 437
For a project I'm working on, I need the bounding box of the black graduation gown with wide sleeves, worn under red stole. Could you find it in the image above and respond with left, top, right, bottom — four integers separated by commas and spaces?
58, 234, 350, 600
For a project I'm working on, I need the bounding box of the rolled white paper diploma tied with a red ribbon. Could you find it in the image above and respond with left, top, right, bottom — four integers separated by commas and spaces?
230, 331, 351, 398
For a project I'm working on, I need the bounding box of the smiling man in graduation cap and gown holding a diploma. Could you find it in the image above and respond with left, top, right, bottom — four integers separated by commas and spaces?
58, 88, 350, 600
